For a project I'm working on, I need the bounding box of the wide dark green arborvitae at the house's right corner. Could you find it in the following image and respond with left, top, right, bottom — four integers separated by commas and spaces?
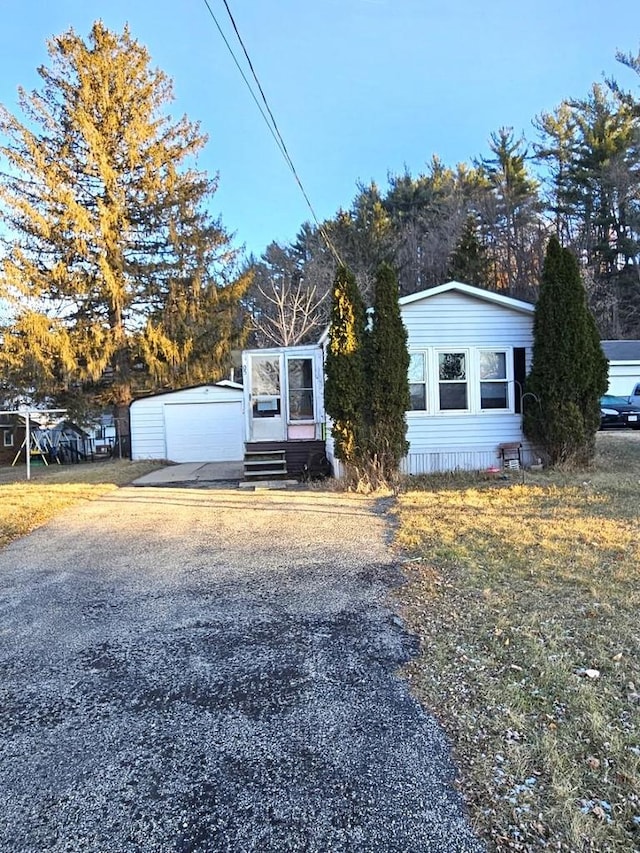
524, 237, 608, 465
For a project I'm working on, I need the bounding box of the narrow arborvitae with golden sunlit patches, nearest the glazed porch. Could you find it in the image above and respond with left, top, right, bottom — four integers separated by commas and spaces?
324, 267, 366, 467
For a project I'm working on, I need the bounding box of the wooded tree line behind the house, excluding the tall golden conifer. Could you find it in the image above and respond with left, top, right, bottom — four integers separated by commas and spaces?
247, 46, 640, 344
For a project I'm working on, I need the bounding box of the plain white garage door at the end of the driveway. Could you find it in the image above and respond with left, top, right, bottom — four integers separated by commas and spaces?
164, 400, 244, 462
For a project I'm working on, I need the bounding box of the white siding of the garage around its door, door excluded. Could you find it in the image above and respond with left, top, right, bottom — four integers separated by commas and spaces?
129, 385, 243, 460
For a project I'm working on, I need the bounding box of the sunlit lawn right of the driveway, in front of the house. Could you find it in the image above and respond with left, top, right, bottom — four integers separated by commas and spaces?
397, 433, 640, 853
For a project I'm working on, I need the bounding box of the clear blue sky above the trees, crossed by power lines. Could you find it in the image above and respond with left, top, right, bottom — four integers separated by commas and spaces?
0, 0, 640, 255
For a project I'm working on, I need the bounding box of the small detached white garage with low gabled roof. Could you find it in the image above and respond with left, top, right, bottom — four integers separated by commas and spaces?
129, 381, 244, 462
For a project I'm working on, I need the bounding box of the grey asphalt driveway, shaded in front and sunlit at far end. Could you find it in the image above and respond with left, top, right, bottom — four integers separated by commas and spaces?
0, 488, 483, 853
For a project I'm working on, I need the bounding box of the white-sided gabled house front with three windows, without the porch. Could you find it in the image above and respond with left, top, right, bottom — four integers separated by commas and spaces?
327, 281, 537, 474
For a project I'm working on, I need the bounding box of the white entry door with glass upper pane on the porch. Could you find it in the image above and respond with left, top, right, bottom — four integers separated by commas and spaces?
249, 354, 287, 441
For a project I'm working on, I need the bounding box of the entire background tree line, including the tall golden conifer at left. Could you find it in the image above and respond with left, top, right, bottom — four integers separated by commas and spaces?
0, 22, 640, 430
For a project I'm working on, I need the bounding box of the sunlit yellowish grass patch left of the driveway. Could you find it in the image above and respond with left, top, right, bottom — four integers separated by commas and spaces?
0, 460, 161, 547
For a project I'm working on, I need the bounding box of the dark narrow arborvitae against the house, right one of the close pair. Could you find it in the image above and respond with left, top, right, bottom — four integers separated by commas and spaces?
366, 263, 410, 482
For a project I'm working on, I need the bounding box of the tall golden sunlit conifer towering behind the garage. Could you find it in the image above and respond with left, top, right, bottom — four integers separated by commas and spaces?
0, 22, 249, 424
